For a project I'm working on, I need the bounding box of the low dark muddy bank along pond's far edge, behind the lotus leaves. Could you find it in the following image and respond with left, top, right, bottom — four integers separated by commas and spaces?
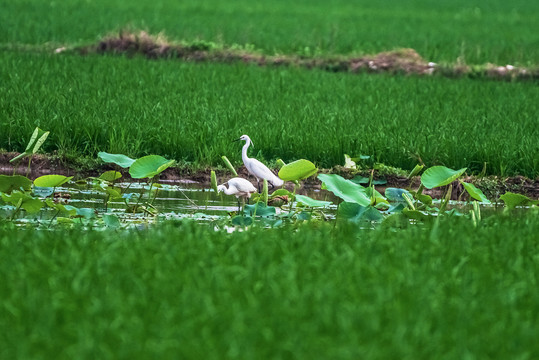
0, 153, 539, 200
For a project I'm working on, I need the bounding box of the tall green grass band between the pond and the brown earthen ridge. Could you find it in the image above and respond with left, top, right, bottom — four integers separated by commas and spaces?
0, 52, 539, 177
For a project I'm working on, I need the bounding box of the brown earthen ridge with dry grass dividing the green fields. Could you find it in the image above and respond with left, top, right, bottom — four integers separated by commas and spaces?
67, 30, 539, 80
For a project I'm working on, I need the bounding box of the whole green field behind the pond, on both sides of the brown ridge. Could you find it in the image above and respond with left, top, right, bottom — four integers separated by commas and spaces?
0, 0, 539, 177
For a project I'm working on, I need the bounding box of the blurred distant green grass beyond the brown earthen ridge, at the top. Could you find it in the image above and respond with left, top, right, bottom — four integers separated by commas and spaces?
0, 0, 539, 65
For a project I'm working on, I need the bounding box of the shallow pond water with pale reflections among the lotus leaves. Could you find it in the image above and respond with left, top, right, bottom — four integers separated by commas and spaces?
0, 181, 516, 228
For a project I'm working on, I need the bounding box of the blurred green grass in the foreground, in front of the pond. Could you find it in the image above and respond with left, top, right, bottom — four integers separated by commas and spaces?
0, 214, 539, 359
